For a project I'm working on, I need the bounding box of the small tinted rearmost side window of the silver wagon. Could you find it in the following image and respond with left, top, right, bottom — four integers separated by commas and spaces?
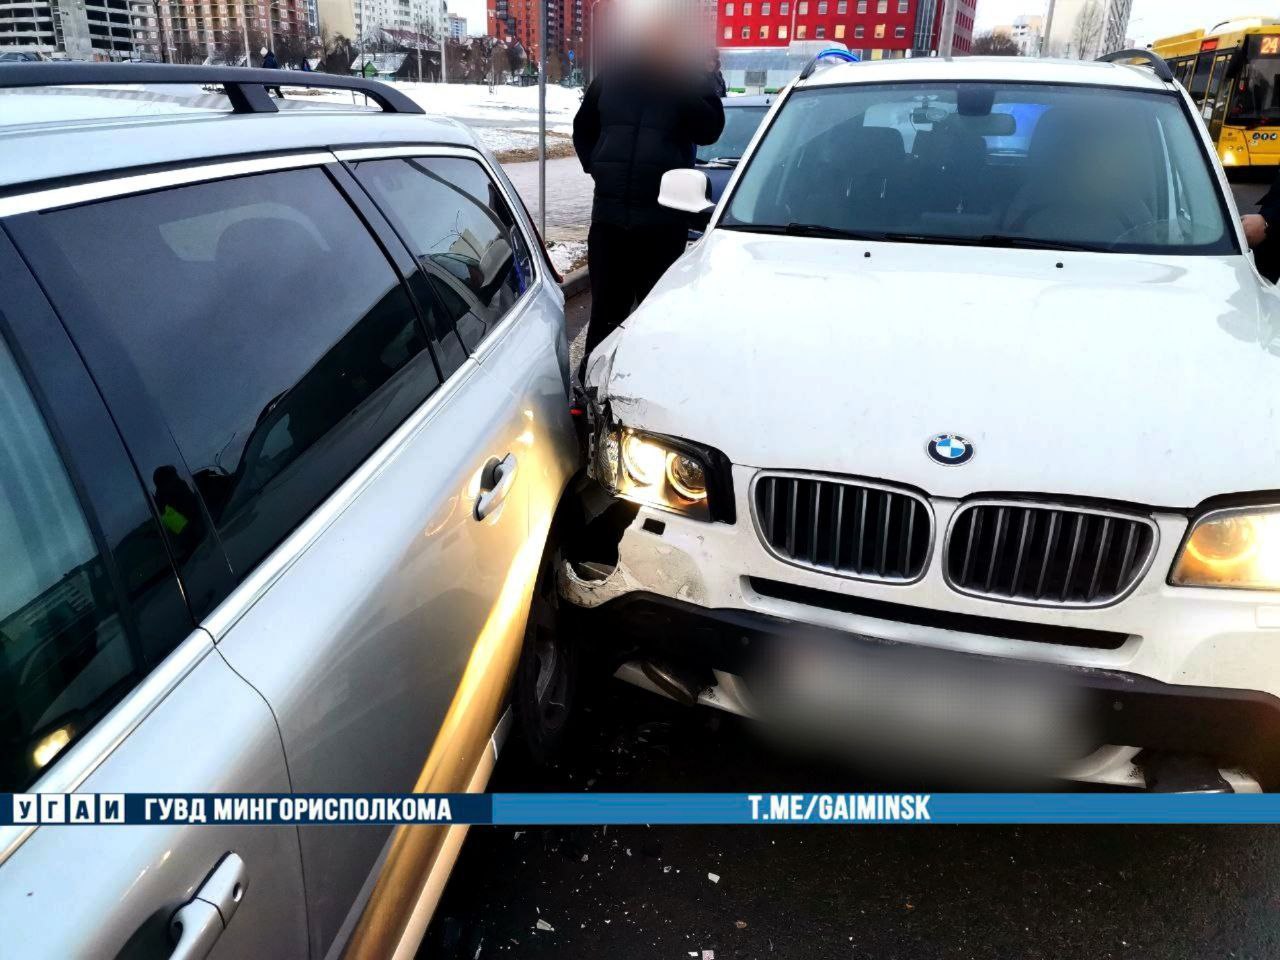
355, 157, 534, 349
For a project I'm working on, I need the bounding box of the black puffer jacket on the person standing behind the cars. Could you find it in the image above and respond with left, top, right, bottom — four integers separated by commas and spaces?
573, 64, 724, 227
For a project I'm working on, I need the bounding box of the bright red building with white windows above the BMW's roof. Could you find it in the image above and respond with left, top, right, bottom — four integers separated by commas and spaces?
716, 0, 978, 60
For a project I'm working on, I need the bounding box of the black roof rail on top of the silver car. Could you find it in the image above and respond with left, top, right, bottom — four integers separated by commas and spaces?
0, 60, 425, 114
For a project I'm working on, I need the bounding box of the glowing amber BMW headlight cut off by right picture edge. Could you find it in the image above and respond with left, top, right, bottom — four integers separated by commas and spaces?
1169, 507, 1280, 590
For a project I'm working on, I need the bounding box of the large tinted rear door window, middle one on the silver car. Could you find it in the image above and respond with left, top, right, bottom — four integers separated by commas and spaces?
30, 169, 439, 573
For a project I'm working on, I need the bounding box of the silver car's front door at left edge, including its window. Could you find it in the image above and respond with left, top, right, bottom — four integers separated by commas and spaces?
0, 230, 307, 960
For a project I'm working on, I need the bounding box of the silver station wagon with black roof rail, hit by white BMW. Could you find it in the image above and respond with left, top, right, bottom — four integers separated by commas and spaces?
0, 64, 579, 960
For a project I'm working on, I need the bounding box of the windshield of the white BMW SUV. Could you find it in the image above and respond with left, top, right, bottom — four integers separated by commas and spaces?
719, 83, 1236, 253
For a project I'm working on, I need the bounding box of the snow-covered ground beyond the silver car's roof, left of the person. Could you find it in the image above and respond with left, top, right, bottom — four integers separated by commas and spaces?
285, 81, 582, 133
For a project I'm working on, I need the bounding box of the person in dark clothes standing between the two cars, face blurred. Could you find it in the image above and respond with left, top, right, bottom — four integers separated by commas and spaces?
573, 42, 724, 378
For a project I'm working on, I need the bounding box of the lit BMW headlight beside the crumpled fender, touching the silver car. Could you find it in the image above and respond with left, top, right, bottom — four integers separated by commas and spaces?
593, 426, 733, 522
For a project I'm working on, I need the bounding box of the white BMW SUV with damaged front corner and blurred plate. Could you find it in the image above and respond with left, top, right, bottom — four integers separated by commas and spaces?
570, 48, 1280, 790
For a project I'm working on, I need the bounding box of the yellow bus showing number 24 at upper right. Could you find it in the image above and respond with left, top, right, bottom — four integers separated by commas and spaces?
1151, 17, 1280, 169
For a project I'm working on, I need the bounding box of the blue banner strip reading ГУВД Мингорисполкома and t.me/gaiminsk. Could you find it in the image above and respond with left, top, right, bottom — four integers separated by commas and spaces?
0, 794, 1280, 828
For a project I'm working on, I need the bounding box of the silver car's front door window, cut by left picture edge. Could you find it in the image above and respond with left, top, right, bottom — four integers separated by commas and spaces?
0, 343, 142, 791
